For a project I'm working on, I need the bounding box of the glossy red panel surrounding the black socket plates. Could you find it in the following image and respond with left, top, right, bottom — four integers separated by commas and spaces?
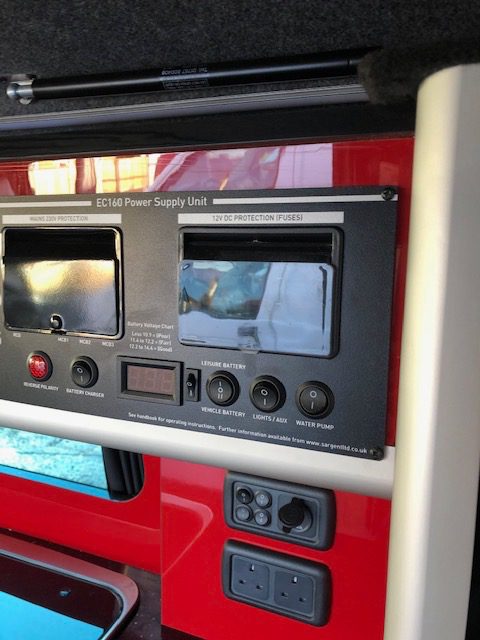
161, 459, 390, 640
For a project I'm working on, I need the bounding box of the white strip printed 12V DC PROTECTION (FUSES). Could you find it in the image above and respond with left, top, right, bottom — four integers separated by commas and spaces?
178, 211, 345, 226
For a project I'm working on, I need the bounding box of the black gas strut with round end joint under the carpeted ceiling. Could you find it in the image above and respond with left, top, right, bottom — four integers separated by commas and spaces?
7, 49, 371, 104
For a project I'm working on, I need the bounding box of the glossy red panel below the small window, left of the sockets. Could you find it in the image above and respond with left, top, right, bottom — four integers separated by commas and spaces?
0, 456, 161, 573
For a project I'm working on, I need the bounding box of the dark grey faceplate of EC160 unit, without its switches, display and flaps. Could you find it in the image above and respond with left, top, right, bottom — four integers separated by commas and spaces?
0, 187, 397, 459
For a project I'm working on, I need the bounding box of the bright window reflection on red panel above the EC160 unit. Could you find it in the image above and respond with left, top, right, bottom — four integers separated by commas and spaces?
0, 143, 333, 196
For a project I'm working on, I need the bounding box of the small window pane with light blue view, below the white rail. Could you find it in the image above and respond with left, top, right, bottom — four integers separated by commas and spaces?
0, 427, 108, 497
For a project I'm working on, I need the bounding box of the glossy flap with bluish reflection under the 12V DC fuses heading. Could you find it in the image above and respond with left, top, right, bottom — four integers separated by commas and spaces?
179, 260, 334, 357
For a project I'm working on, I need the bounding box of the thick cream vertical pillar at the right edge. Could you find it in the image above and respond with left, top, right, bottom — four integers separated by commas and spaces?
384, 64, 480, 640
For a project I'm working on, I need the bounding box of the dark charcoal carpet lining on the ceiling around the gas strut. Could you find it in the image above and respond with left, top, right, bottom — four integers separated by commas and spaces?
0, 0, 480, 115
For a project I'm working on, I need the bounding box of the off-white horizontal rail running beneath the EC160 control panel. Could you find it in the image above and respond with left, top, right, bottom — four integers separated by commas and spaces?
0, 400, 394, 500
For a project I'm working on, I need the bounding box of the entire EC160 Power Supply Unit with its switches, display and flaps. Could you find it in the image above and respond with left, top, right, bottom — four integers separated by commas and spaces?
0, 187, 397, 458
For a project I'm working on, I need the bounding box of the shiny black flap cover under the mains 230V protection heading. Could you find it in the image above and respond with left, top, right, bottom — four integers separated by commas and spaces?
4, 228, 120, 336
